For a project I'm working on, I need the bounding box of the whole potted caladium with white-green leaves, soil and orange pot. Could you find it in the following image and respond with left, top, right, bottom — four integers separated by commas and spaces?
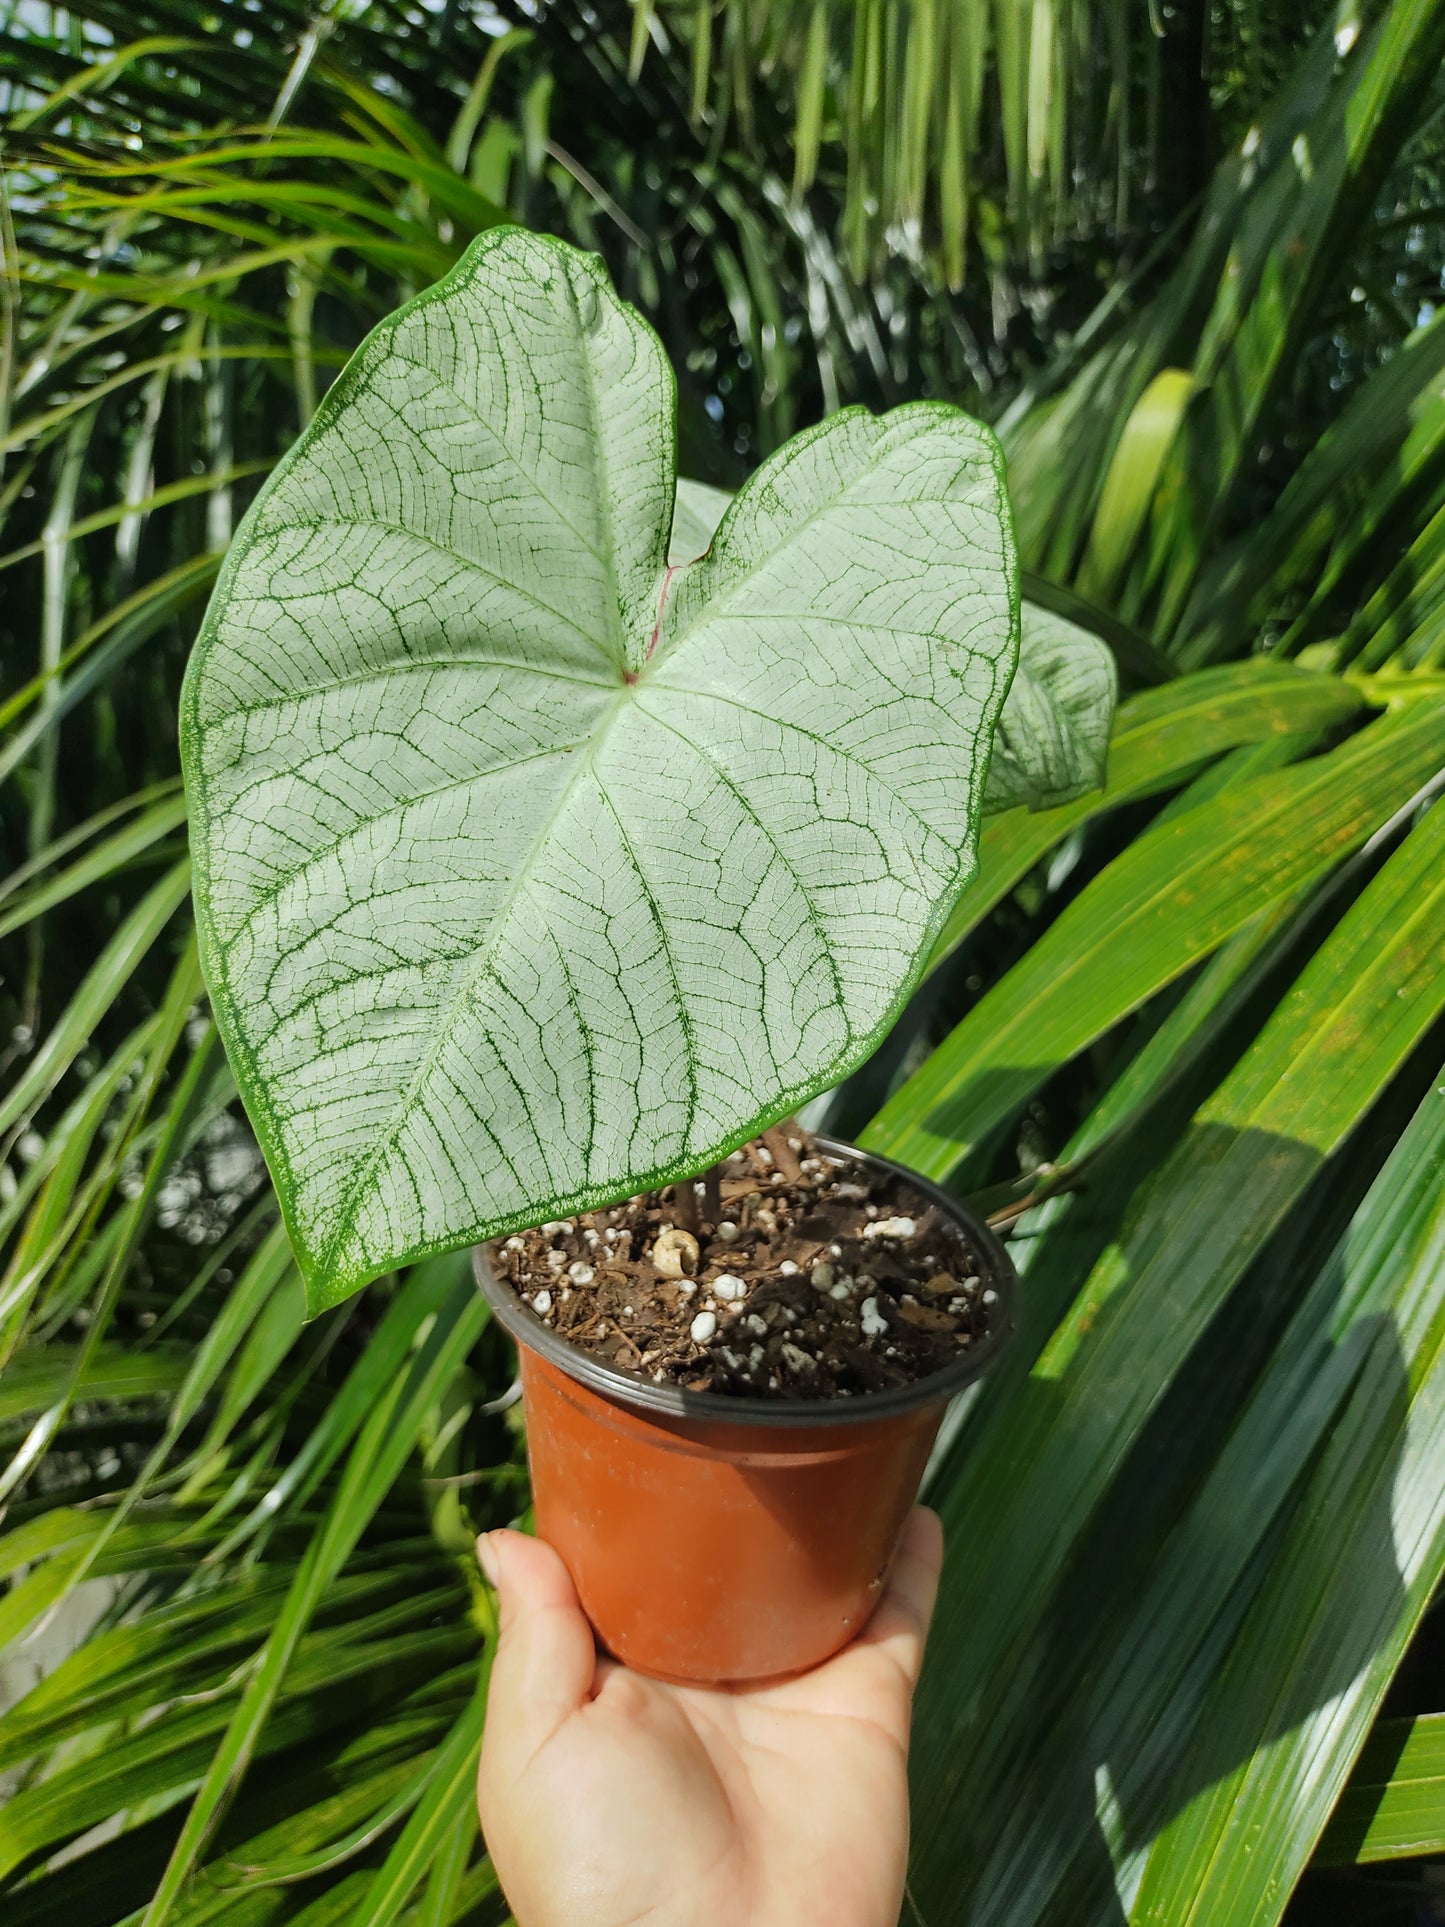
181, 227, 1114, 1678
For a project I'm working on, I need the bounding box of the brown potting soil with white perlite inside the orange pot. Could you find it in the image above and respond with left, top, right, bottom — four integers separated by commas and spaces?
491, 1127, 996, 1399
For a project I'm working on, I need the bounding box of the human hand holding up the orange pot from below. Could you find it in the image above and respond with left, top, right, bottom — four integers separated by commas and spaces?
478, 1507, 942, 1927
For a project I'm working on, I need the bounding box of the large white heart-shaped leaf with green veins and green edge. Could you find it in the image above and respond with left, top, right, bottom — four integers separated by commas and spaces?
183, 229, 1017, 1305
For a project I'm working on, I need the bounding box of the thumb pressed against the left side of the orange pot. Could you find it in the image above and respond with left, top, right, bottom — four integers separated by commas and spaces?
478, 1532, 597, 1771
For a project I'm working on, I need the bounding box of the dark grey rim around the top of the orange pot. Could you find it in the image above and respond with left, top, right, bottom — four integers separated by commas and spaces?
472, 1133, 1017, 1428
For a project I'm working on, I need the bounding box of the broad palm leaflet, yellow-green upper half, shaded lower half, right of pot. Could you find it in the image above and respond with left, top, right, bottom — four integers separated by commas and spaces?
919, 790, 1445, 1917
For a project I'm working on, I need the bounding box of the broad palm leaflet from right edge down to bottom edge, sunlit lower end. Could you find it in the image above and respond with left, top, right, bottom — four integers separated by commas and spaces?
1131, 1071, 1445, 1927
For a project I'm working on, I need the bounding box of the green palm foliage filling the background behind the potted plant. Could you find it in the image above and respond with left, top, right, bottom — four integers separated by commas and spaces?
0, 0, 1445, 1927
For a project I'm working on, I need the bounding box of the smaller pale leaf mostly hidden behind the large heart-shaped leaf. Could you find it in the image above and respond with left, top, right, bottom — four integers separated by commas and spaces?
667, 476, 1119, 815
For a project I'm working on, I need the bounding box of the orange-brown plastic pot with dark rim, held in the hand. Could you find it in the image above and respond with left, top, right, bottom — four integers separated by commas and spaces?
474, 1139, 1015, 1684
